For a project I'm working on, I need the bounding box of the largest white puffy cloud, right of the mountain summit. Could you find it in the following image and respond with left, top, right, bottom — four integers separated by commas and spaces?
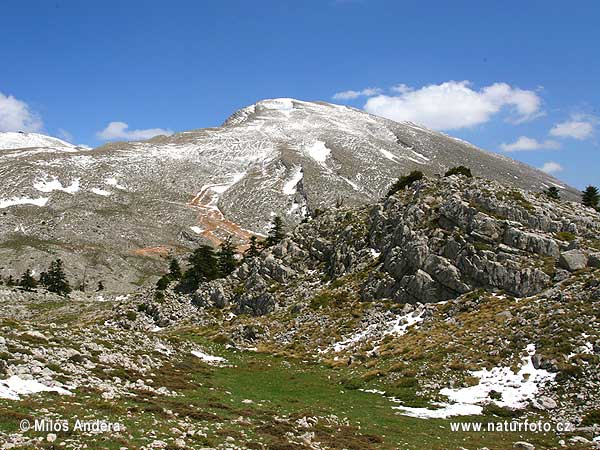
364, 81, 542, 130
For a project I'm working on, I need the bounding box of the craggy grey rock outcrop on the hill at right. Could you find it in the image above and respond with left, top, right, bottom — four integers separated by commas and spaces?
184, 177, 600, 315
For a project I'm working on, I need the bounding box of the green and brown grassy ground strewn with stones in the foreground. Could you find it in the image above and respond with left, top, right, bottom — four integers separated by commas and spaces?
0, 329, 576, 450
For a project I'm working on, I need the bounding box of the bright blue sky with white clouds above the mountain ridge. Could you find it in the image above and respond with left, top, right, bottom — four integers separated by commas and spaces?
0, 0, 600, 188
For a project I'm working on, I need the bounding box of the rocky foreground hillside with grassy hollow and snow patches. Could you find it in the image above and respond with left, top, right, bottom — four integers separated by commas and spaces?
0, 175, 600, 450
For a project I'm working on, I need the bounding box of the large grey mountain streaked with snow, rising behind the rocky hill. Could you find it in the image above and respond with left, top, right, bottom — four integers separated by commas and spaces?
0, 99, 577, 290
